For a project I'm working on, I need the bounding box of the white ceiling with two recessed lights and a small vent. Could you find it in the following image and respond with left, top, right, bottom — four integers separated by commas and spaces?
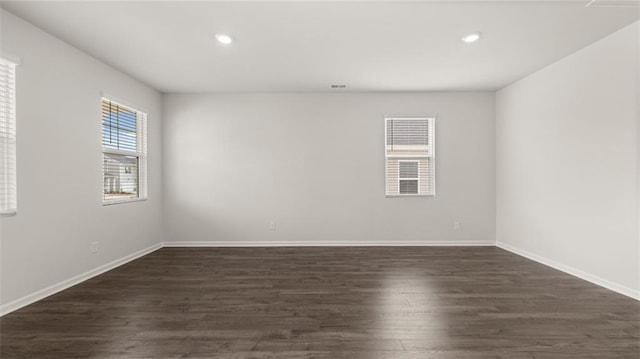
1, 0, 640, 92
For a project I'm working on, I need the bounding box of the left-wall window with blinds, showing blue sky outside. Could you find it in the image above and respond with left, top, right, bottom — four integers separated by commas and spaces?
102, 98, 147, 204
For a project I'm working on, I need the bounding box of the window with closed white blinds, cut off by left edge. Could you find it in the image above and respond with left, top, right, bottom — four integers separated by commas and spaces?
0, 58, 18, 215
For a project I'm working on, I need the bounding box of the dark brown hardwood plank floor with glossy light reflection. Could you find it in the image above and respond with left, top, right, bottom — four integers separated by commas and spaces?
0, 247, 640, 359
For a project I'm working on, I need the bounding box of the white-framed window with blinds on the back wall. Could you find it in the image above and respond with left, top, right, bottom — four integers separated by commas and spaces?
385, 118, 435, 197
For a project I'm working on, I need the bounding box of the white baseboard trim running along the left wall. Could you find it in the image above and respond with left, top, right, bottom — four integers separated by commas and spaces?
0, 243, 162, 317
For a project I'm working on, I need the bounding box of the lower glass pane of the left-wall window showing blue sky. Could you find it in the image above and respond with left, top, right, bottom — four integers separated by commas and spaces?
103, 153, 138, 200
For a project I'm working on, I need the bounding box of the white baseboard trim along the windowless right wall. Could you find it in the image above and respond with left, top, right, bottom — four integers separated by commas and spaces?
496, 241, 640, 300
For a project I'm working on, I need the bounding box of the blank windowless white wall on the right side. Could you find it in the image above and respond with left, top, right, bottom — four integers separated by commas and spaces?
496, 22, 640, 296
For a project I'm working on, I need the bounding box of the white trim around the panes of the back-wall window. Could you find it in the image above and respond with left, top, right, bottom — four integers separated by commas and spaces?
383, 114, 438, 198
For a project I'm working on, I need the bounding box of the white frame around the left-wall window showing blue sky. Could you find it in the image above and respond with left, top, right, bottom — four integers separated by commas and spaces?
100, 97, 149, 206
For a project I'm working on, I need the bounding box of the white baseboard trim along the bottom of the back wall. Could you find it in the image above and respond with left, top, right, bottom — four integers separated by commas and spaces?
163, 241, 496, 247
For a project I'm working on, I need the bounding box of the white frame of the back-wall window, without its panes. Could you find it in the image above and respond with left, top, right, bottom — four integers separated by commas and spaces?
383, 114, 437, 198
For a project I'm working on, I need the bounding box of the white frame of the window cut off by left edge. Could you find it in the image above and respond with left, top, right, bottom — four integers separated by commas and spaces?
0, 54, 20, 217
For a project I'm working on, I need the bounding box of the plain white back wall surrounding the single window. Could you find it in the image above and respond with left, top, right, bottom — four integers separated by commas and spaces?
163, 92, 495, 244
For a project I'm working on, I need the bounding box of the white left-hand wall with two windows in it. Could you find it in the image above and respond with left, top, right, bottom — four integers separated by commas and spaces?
0, 10, 162, 307
